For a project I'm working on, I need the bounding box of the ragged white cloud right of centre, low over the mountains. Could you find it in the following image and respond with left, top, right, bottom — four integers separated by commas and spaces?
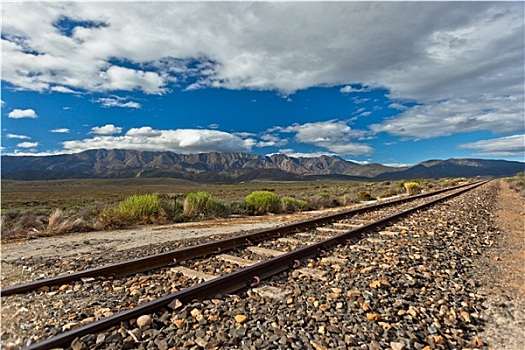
278, 120, 373, 155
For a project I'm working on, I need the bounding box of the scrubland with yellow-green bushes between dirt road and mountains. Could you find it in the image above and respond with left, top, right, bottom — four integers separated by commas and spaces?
1, 175, 470, 238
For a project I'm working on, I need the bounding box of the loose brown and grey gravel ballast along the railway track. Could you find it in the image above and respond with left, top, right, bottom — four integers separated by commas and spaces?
2, 182, 524, 350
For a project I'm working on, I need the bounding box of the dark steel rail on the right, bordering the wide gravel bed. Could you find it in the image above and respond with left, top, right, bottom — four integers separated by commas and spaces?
25, 181, 488, 350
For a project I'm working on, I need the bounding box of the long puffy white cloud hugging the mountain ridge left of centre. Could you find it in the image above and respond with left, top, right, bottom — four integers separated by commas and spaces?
63, 126, 255, 153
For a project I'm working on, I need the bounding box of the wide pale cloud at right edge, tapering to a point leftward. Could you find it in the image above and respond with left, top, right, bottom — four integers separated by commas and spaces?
371, 96, 525, 139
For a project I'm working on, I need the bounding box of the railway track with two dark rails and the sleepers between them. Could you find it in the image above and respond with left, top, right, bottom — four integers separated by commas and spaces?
1, 182, 485, 349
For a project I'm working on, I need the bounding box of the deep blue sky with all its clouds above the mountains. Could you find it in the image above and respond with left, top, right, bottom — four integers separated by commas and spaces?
1, 2, 525, 165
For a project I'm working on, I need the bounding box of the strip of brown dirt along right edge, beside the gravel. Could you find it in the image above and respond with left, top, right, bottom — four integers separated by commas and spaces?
480, 181, 525, 350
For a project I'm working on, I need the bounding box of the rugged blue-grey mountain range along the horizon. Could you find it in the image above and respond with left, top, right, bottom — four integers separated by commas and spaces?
1, 149, 525, 182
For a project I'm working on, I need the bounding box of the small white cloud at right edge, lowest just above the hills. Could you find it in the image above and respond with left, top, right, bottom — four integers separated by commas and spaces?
459, 134, 525, 157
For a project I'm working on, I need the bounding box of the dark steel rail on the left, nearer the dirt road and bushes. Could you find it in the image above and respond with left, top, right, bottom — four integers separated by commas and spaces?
0, 182, 479, 296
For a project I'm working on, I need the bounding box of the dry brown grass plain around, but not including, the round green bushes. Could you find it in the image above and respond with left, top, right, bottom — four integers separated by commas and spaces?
1, 179, 457, 238
